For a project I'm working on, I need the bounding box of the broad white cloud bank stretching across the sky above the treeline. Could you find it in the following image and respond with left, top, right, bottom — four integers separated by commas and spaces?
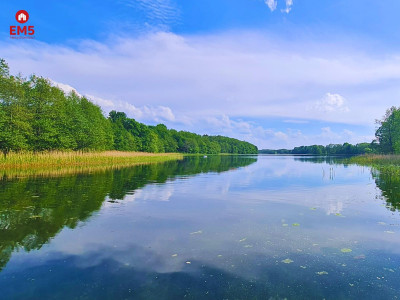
0, 32, 400, 148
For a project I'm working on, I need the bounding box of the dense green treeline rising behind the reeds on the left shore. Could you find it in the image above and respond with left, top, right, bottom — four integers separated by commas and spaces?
0, 59, 258, 155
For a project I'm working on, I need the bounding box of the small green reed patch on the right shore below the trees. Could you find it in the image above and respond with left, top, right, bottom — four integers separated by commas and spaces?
348, 154, 400, 175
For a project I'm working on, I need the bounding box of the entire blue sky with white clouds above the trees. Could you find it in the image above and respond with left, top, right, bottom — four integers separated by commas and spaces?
0, 0, 400, 148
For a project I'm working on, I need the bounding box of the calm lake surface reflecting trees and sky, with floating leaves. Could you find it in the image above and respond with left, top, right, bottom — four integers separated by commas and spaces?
0, 156, 400, 299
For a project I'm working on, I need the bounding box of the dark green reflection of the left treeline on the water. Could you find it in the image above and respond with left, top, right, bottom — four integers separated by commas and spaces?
0, 156, 257, 270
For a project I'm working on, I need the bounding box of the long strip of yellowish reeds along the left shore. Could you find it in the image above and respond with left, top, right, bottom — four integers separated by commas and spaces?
0, 151, 183, 175
